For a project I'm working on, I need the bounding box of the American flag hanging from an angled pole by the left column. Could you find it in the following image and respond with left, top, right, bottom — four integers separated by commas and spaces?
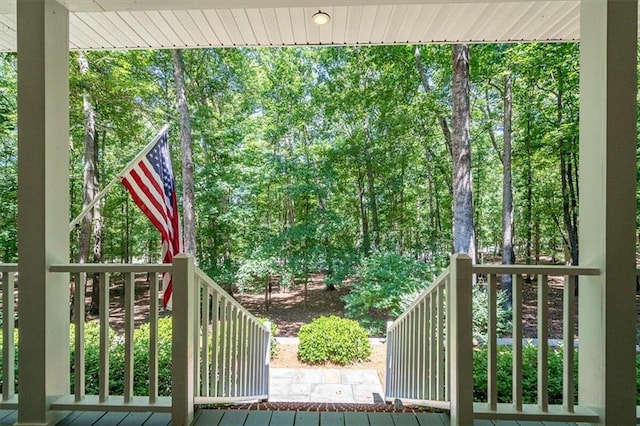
121, 131, 182, 307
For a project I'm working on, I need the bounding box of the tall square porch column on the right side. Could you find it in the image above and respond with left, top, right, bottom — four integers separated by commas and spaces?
579, 0, 638, 425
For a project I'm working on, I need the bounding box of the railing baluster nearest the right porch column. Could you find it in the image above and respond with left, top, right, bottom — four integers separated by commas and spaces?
562, 275, 576, 413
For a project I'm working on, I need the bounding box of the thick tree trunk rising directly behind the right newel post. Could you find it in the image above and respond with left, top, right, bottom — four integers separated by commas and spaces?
451, 44, 476, 262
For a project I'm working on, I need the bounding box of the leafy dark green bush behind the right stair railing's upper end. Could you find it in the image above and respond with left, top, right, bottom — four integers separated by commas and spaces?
345, 252, 442, 334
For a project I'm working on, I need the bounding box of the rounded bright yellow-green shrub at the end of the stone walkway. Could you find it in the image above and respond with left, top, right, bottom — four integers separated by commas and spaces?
298, 315, 373, 365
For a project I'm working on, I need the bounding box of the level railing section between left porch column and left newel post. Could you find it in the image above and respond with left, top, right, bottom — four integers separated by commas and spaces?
49, 263, 172, 412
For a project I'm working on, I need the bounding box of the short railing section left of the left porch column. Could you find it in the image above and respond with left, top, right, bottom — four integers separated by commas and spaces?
0, 263, 18, 409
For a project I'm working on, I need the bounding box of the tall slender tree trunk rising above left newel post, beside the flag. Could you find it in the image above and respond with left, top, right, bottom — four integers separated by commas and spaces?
171, 49, 196, 257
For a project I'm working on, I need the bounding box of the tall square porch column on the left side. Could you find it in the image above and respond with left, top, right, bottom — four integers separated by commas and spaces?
17, 0, 69, 425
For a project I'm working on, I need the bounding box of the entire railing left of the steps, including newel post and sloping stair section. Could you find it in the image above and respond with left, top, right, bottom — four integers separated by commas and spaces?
43, 255, 270, 425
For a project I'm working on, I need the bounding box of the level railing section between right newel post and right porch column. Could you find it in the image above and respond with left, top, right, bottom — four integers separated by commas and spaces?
473, 265, 600, 422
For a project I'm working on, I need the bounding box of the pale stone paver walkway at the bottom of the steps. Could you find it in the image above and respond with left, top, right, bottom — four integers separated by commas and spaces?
269, 368, 384, 404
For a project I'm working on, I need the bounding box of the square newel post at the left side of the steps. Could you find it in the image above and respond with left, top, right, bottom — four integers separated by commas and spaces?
171, 254, 196, 426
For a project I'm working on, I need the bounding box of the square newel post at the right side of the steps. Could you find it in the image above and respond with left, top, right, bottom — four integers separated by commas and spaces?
447, 253, 473, 425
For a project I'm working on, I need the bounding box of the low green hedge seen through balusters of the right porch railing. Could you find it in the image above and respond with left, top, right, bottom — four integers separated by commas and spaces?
473, 345, 576, 404
